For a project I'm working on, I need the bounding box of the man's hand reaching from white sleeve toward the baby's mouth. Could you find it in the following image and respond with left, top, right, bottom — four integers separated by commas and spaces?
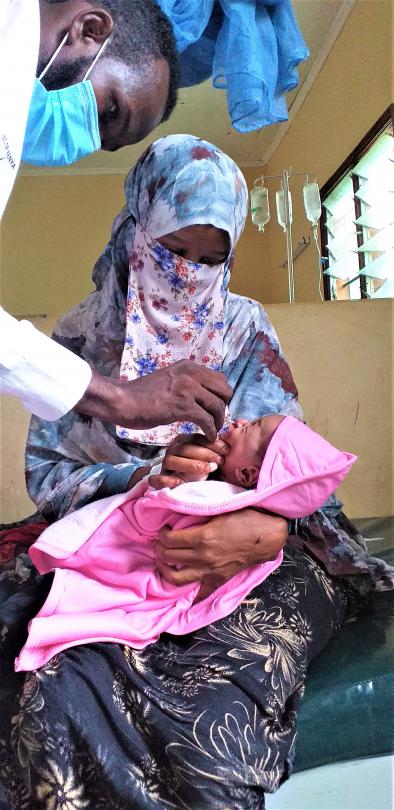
75, 360, 232, 442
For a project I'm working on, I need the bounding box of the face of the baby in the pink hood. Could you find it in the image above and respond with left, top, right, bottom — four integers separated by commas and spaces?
220, 415, 284, 486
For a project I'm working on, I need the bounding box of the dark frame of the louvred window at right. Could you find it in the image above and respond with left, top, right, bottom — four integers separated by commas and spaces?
320, 104, 394, 301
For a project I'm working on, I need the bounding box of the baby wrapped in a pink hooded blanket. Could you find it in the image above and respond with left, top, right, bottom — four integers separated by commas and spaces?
16, 415, 355, 670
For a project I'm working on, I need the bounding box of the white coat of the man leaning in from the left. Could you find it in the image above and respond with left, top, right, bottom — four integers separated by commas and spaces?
0, 0, 91, 420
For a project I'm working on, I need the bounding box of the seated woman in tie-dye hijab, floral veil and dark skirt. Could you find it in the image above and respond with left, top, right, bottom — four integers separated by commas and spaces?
0, 135, 390, 810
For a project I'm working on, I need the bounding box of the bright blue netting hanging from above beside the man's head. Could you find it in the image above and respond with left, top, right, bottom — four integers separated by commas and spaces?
158, 0, 309, 132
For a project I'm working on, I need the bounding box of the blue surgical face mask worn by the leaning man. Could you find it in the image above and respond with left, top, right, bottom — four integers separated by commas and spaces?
22, 34, 109, 166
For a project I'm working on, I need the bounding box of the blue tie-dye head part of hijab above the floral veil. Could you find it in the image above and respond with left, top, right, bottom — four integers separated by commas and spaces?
125, 135, 248, 252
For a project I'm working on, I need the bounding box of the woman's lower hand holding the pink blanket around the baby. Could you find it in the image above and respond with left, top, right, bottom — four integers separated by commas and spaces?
156, 509, 287, 601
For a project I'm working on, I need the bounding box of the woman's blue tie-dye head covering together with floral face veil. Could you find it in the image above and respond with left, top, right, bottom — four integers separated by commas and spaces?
117, 135, 248, 446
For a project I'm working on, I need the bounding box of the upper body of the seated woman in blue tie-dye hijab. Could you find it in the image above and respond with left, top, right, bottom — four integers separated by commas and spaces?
26, 135, 301, 520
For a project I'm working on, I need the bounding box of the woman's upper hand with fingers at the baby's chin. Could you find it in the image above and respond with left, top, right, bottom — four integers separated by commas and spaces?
149, 433, 229, 489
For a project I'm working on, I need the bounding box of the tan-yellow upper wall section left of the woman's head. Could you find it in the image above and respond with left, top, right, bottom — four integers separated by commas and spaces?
1, 175, 123, 315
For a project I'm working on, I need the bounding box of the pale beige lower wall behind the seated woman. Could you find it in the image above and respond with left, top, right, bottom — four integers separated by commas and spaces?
0, 300, 394, 520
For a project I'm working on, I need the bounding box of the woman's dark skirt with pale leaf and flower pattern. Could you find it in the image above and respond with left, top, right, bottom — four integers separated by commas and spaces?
0, 546, 354, 810
